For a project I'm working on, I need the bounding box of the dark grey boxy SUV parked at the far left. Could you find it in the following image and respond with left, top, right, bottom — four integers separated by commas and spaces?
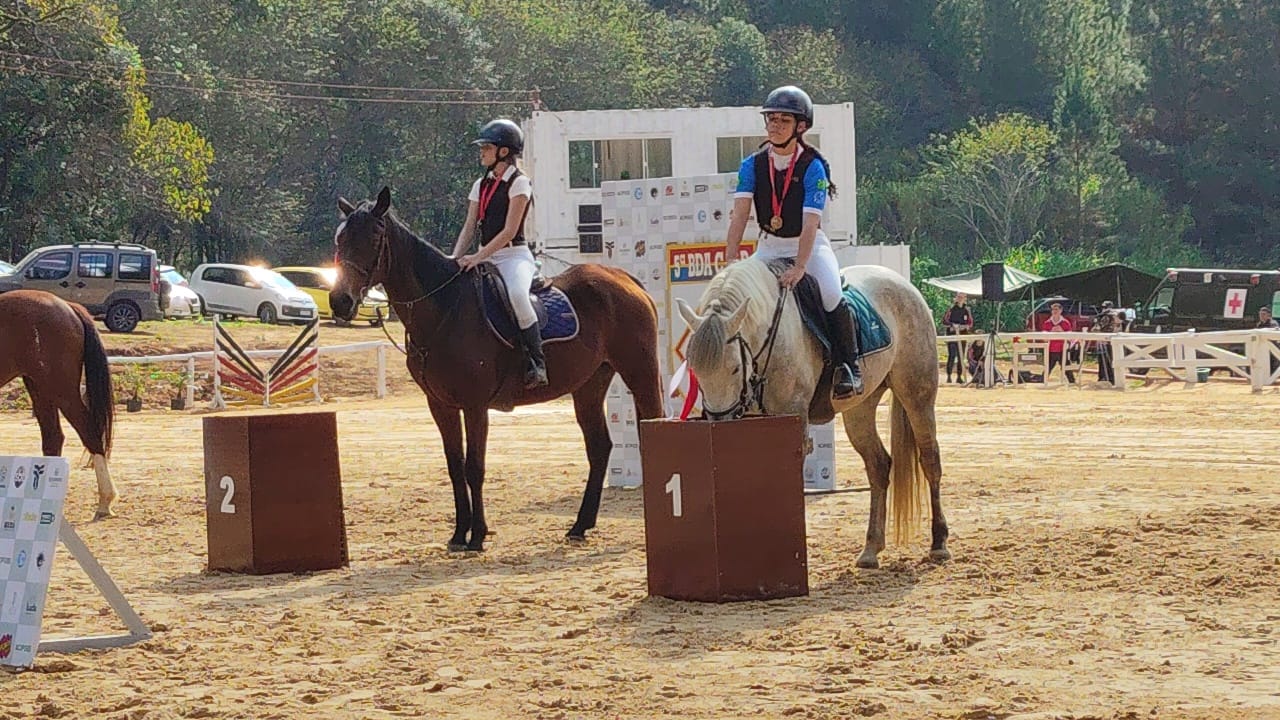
0, 242, 163, 333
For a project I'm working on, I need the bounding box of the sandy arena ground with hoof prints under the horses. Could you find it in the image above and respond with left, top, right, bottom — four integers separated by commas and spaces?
0, 328, 1280, 720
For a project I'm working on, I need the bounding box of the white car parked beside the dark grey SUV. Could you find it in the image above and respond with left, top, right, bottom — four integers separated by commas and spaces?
188, 263, 316, 323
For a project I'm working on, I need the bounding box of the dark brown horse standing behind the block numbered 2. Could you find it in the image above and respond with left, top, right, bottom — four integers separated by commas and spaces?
329, 187, 662, 551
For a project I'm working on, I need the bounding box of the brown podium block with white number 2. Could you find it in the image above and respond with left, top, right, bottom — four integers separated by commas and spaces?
204, 413, 347, 574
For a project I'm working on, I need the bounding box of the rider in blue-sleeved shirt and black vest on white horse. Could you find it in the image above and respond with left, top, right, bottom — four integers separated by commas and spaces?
726, 85, 863, 400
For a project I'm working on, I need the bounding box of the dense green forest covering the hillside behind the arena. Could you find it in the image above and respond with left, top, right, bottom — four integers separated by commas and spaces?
0, 0, 1280, 279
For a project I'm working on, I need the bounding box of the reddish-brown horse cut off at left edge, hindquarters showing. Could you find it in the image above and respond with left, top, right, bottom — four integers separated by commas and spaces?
0, 290, 115, 520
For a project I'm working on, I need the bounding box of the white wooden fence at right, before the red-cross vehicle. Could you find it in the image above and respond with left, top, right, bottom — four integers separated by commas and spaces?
938, 329, 1280, 391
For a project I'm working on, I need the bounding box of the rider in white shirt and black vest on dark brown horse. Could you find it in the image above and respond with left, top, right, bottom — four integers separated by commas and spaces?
453, 119, 547, 388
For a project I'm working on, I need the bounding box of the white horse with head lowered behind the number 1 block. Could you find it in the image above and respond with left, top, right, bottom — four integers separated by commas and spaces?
676, 256, 951, 568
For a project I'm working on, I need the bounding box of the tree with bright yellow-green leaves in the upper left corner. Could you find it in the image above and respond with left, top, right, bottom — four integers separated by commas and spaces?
0, 0, 210, 256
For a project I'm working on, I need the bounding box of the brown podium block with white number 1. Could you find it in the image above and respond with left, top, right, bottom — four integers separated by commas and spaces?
640, 415, 809, 602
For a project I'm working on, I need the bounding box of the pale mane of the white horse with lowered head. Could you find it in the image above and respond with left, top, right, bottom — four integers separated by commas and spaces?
685, 258, 778, 368
